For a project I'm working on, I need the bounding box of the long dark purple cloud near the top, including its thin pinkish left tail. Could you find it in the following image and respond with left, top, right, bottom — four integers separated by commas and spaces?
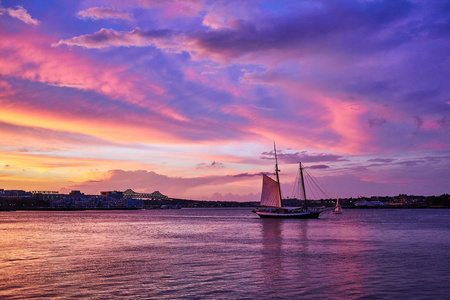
55, 1, 418, 58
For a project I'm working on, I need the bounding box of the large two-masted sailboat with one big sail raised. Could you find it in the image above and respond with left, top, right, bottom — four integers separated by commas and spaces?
253, 143, 325, 219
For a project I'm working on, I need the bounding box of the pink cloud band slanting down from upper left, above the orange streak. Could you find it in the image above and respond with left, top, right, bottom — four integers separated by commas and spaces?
0, 27, 200, 121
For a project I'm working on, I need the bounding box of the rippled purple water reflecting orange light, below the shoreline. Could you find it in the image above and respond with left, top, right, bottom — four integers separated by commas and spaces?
0, 208, 450, 299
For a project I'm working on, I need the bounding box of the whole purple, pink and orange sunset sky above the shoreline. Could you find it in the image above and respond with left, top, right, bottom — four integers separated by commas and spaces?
0, 0, 450, 201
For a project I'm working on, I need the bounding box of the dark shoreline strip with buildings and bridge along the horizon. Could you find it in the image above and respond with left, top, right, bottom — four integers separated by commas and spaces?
0, 189, 450, 211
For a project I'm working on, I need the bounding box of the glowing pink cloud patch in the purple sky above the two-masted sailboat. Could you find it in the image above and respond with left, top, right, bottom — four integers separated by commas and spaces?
239, 64, 394, 154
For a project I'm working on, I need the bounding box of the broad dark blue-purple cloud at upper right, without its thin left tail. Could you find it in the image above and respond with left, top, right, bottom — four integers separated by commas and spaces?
197, 1, 412, 57
